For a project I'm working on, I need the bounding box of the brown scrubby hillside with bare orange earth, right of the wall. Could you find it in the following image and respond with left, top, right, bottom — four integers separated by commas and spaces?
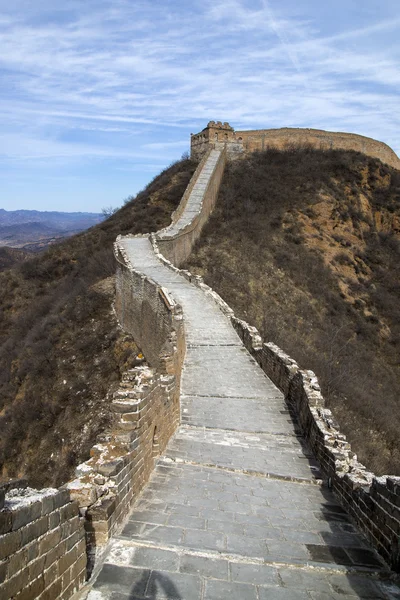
185, 148, 400, 474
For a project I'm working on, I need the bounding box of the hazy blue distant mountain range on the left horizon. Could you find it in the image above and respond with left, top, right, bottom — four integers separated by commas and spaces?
0, 208, 104, 252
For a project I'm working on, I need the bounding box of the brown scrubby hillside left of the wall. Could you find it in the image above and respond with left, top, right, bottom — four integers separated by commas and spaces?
0, 160, 196, 486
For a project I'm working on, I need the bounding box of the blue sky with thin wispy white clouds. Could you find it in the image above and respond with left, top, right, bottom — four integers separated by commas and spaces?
0, 0, 400, 212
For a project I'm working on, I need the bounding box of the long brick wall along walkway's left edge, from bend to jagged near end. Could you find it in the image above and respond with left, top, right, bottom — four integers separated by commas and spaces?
67, 241, 186, 570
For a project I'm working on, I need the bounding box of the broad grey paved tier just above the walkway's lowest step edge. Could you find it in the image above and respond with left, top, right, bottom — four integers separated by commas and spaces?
113, 458, 384, 571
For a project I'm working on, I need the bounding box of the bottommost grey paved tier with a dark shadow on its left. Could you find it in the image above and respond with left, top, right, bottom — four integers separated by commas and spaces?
88, 541, 399, 600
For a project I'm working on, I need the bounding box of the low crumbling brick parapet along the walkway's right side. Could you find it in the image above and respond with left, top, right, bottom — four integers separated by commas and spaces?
153, 258, 400, 573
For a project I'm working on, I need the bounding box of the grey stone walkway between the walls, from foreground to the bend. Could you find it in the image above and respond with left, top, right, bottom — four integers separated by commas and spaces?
88, 238, 400, 600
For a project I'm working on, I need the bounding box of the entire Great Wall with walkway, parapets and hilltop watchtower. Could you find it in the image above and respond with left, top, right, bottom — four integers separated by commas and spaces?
0, 122, 400, 600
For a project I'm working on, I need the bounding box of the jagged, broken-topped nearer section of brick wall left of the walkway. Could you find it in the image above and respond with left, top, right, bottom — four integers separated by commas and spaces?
67, 358, 180, 570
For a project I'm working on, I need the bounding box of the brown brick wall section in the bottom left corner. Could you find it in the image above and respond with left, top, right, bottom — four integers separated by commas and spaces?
0, 487, 86, 600
